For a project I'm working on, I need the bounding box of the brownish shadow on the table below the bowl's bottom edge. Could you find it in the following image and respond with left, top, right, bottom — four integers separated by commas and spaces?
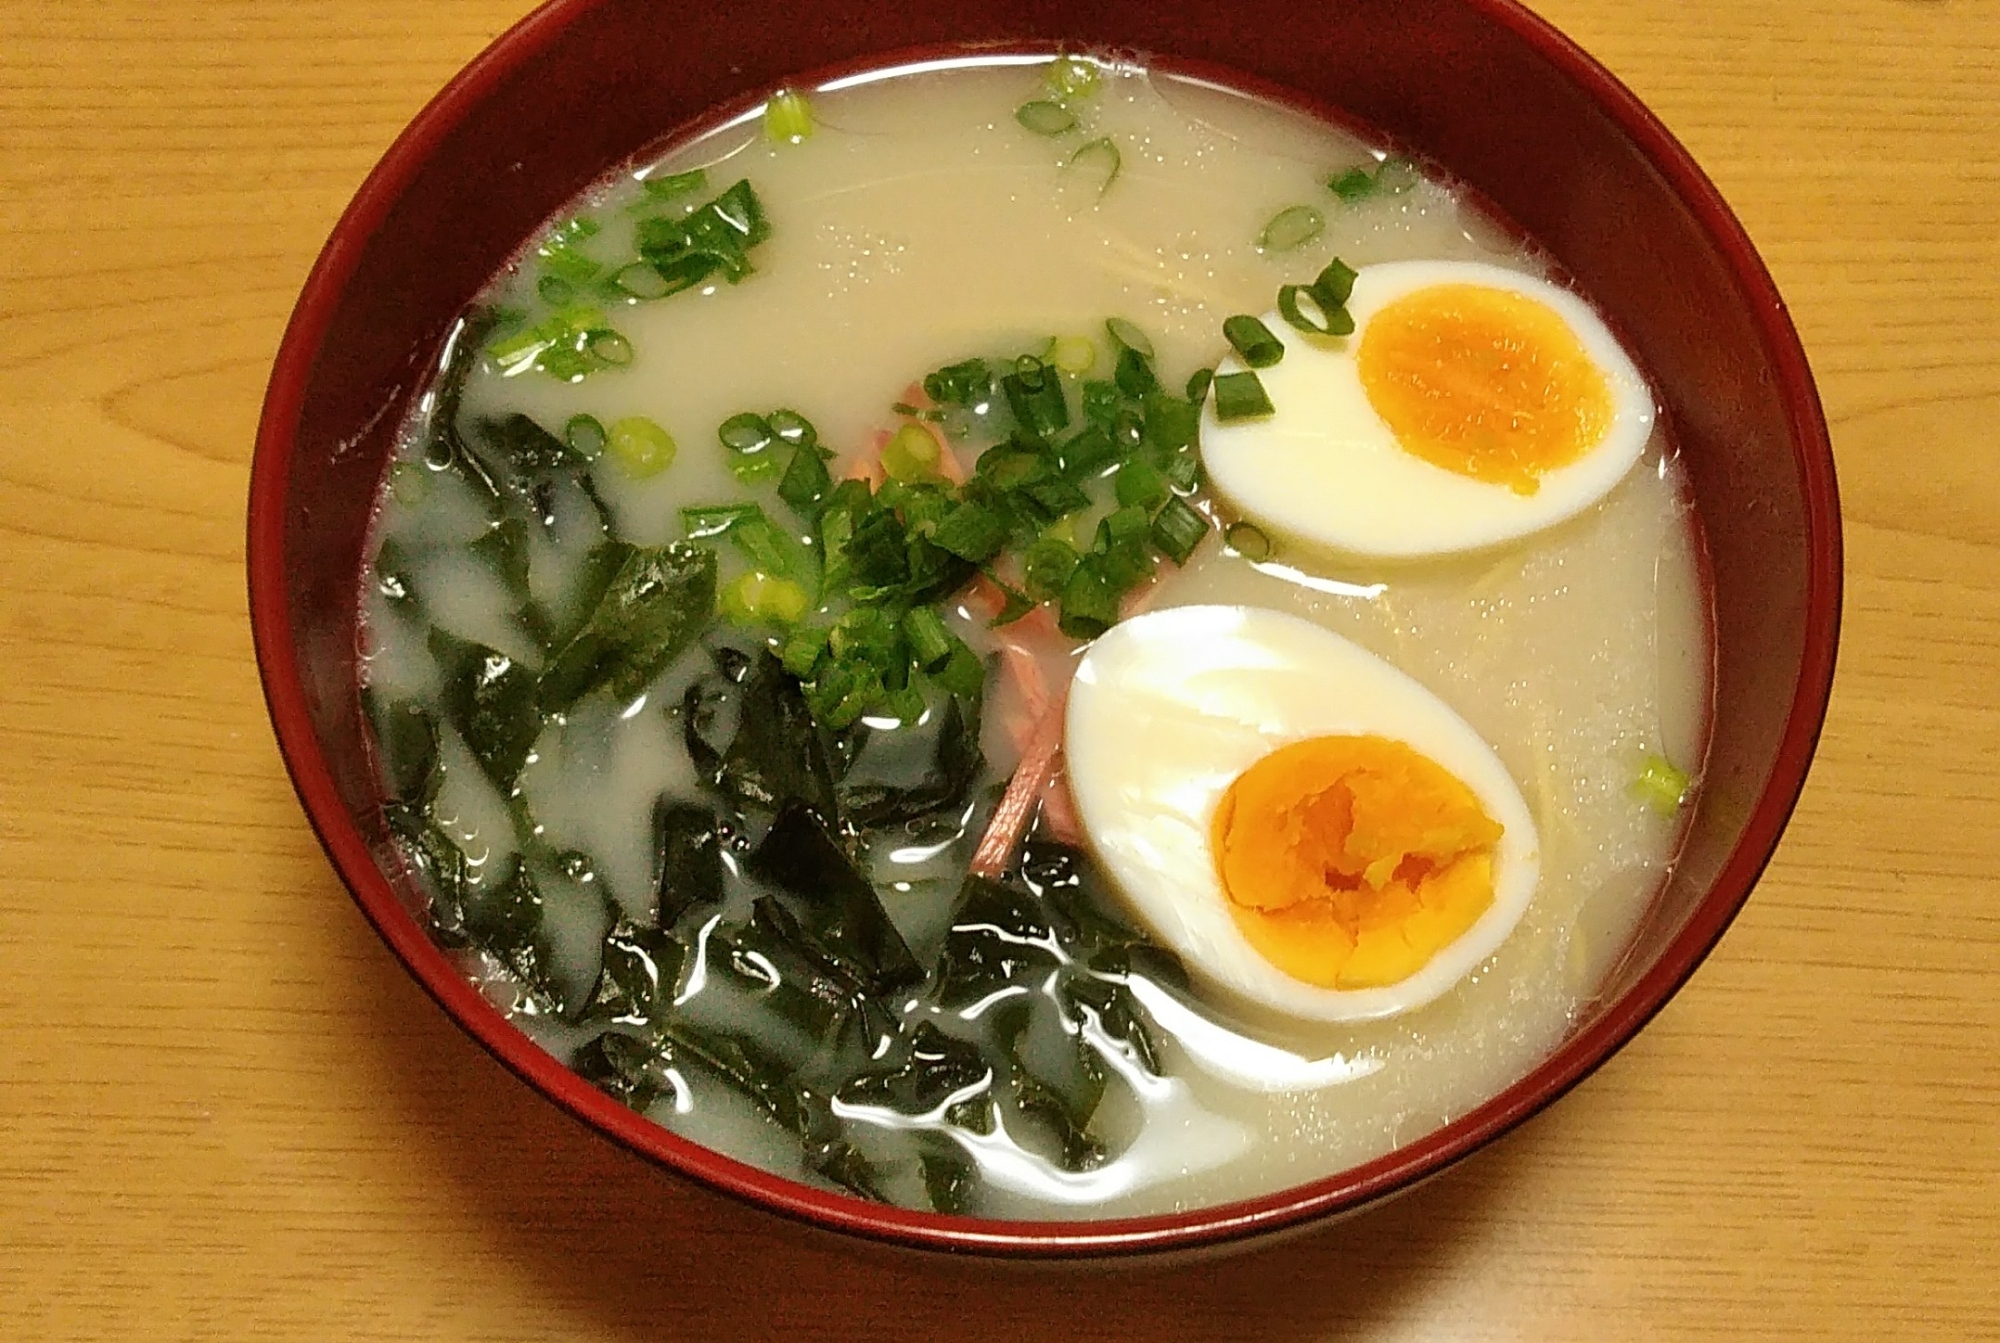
328, 873, 1524, 1343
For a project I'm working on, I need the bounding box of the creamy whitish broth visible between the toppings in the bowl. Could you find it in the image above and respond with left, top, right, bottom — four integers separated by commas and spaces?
364, 57, 1708, 1217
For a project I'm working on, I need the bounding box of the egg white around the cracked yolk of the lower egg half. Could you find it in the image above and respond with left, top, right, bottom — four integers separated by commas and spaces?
1064, 606, 1540, 1021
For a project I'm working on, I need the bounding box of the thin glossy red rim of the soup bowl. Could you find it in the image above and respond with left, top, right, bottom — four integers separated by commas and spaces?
246, 0, 1842, 1259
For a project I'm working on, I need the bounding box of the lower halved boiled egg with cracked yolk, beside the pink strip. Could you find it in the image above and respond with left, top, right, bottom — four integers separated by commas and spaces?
1064, 606, 1540, 1021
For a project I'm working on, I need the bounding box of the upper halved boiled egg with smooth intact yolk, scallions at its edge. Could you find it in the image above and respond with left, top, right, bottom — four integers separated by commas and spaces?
1202, 262, 1656, 558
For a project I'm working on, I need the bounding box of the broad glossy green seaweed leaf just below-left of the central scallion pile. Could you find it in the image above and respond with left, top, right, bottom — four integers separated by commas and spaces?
536, 542, 716, 713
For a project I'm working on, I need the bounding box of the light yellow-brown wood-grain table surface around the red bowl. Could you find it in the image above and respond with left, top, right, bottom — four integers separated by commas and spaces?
0, 0, 2000, 1343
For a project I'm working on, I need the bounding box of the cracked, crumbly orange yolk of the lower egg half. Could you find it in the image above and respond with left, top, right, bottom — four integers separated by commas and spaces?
1210, 737, 1500, 989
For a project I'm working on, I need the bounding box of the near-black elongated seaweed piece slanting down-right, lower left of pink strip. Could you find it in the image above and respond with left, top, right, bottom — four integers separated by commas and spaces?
750, 801, 924, 993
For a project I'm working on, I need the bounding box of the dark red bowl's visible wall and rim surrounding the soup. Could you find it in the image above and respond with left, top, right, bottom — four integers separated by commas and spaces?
248, 0, 1840, 1257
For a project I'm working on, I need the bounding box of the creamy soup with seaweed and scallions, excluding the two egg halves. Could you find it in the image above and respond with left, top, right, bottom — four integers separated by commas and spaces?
362, 60, 1708, 1217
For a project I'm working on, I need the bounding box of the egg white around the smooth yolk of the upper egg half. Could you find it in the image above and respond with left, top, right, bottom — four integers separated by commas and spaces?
1202, 262, 1658, 560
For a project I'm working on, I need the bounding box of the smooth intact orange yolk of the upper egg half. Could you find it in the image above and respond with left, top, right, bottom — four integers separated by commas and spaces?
1356, 284, 1612, 494
